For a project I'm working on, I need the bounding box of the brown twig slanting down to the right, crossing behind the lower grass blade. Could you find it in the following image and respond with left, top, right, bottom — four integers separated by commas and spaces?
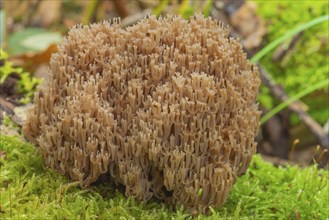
258, 65, 329, 148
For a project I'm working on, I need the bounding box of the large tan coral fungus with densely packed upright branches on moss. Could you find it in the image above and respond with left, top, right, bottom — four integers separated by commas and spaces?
24, 15, 260, 212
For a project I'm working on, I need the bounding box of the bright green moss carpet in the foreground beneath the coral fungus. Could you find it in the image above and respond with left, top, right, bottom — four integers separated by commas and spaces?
0, 135, 329, 220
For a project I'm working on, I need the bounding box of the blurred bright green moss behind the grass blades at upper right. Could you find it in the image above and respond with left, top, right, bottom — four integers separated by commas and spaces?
256, 0, 329, 124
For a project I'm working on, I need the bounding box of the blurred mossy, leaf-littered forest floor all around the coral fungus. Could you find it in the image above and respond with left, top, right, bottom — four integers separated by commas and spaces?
0, 0, 329, 219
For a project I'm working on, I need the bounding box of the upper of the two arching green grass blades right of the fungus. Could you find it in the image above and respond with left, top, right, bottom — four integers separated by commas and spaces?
250, 15, 329, 63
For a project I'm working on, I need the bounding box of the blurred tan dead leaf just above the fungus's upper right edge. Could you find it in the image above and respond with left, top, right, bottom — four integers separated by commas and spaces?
230, 1, 266, 50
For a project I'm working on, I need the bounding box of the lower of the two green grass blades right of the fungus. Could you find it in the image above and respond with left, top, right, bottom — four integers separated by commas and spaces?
260, 79, 329, 125
